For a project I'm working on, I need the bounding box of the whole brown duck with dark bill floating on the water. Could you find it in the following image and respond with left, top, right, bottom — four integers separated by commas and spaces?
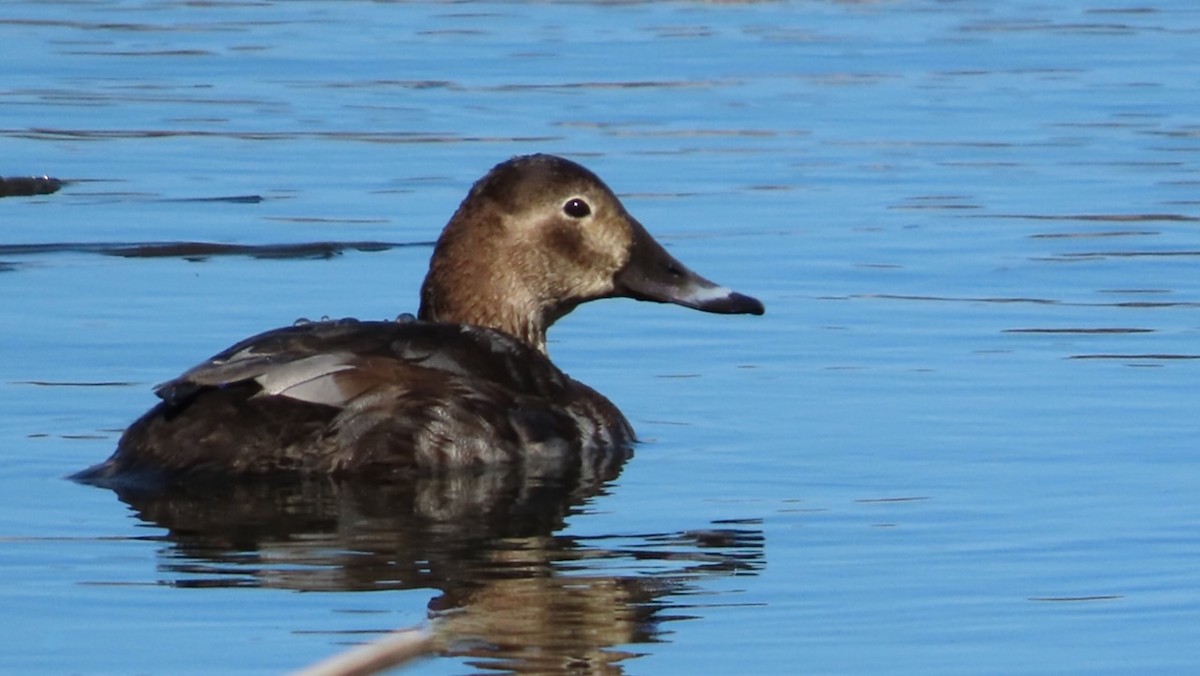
72, 154, 764, 487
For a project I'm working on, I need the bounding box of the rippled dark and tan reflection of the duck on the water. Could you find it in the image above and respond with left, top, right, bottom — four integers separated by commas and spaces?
108, 465, 764, 674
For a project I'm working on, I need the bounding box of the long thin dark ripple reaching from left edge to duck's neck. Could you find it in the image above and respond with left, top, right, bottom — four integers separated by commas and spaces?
0, 241, 433, 261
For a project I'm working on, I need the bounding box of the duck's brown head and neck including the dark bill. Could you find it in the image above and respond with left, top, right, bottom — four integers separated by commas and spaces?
419, 155, 763, 352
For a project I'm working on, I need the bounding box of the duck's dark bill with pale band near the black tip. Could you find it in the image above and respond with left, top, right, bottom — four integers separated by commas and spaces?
614, 223, 764, 315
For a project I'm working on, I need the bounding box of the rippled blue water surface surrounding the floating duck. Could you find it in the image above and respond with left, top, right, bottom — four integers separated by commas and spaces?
0, 0, 1200, 674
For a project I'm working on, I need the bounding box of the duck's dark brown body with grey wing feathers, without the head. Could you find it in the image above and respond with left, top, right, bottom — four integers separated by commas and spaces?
76, 319, 634, 484
